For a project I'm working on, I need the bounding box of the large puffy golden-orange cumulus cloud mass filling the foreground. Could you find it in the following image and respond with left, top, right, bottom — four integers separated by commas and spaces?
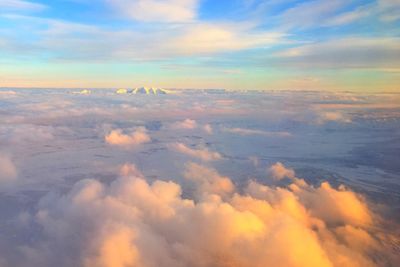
11, 163, 399, 267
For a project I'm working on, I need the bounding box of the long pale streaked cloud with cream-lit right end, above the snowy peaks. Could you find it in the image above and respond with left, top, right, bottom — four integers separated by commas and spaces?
4, 15, 286, 62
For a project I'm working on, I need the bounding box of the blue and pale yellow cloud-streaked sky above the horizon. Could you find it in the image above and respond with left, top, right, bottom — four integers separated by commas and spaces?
0, 0, 400, 93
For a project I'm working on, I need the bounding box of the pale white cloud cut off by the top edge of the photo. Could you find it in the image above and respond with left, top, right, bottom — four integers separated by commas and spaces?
106, 0, 199, 23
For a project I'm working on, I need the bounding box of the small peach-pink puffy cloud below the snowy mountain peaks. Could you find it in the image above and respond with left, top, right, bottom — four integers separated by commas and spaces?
104, 127, 151, 147
